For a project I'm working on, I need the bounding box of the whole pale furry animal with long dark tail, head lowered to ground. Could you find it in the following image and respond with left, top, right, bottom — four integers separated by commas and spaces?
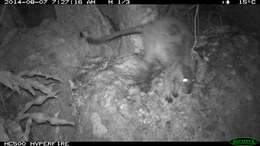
80, 17, 193, 96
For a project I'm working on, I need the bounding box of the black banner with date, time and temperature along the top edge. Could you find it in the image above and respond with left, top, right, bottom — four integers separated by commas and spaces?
1, 0, 244, 5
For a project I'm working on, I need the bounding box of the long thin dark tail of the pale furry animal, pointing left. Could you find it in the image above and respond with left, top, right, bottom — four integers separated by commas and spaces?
80, 25, 143, 44
